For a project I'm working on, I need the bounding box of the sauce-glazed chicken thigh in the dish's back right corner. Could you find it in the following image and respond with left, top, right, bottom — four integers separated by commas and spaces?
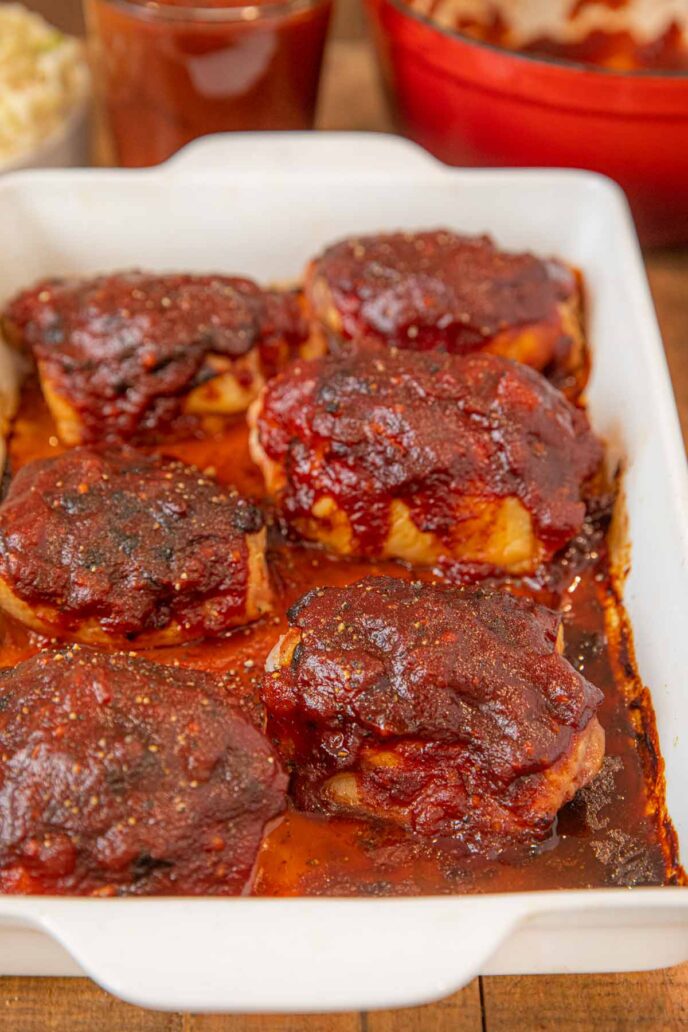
305, 230, 584, 370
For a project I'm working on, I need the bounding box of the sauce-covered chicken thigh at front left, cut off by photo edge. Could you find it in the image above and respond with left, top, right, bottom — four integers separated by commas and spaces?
0, 646, 287, 896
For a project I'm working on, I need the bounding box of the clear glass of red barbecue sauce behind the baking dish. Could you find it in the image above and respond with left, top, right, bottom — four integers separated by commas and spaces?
85, 0, 331, 166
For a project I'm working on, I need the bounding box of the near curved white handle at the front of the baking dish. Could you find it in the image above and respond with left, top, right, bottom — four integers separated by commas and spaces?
0, 897, 523, 1012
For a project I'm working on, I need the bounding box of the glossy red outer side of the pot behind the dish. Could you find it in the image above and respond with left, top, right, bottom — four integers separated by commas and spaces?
366, 0, 688, 245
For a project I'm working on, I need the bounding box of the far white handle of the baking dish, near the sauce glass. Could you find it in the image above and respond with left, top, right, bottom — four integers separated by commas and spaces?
162, 132, 449, 181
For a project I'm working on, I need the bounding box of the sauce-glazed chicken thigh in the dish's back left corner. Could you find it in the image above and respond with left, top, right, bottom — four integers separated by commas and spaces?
4, 271, 306, 445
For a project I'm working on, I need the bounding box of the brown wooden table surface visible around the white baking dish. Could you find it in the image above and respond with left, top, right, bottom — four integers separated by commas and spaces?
8, 6, 688, 1032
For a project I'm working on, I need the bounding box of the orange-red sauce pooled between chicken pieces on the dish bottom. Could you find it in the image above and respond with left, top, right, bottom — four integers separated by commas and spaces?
0, 383, 683, 896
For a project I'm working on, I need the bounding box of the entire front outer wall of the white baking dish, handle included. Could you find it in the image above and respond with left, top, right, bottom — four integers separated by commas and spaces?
0, 888, 688, 1013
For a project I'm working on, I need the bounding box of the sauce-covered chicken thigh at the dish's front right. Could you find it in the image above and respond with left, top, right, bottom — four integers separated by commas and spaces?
263, 577, 604, 854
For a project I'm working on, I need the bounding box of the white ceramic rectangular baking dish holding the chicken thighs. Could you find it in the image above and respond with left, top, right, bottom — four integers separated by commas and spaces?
0, 134, 688, 1011
